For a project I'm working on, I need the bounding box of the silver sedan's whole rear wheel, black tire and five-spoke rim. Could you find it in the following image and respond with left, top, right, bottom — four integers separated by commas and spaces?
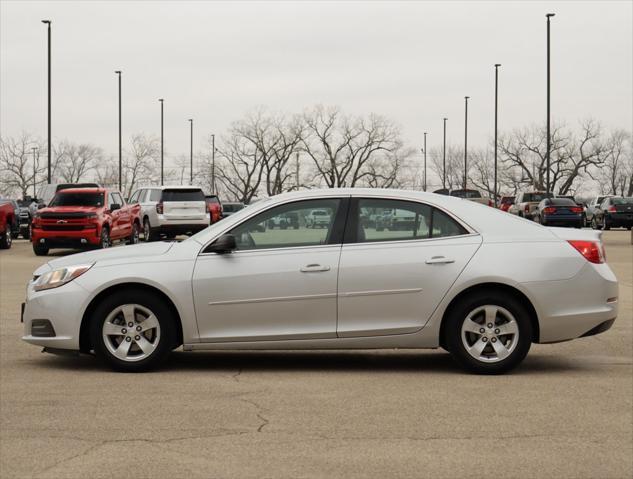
444, 292, 533, 374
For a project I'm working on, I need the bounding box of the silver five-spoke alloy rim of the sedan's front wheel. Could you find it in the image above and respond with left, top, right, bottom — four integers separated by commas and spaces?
102, 304, 160, 362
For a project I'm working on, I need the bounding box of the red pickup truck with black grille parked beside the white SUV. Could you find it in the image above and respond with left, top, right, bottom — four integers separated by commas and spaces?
31, 188, 141, 256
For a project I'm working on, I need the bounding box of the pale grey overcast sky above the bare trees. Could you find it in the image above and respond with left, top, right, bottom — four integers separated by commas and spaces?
0, 0, 633, 171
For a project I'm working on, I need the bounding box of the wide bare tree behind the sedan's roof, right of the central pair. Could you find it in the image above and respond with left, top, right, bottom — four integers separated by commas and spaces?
301, 106, 403, 188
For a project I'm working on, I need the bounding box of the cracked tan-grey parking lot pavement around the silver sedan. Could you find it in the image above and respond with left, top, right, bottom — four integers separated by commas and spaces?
0, 230, 633, 478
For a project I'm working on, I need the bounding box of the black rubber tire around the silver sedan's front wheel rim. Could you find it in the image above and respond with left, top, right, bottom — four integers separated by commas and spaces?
90, 289, 177, 372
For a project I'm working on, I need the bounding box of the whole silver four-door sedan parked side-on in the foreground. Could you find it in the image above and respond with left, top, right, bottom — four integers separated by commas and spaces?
22, 189, 618, 374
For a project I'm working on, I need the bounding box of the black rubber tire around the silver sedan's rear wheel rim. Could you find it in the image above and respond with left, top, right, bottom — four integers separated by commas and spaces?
443, 291, 534, 374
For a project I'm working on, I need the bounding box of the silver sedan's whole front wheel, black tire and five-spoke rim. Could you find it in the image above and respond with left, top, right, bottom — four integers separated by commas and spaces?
90, 291, 176, 372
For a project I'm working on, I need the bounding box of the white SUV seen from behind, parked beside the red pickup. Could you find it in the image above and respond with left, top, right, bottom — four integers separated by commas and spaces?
129, 186, 210, 241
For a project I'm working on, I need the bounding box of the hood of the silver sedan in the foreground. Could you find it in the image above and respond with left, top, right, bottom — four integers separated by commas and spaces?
48, 241, 174, 269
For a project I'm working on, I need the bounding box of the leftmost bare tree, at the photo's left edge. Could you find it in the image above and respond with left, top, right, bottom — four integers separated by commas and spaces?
0, 133, 46, 196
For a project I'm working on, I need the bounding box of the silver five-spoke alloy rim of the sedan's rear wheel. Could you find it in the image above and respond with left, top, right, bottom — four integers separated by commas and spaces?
461, 304, 519, 363
